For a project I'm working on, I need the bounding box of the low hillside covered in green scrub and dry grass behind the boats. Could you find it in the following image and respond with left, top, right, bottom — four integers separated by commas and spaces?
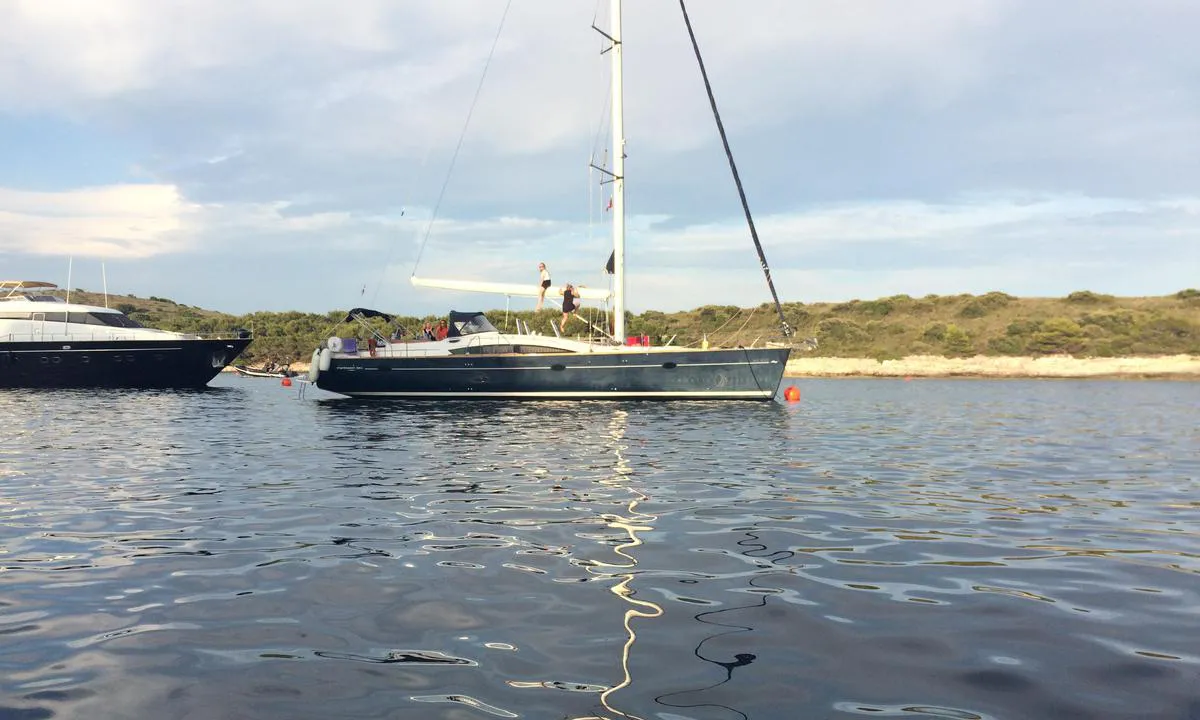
49, 289, 1200, 362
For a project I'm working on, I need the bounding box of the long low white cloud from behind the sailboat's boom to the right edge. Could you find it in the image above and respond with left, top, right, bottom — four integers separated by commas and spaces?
388, 193, 1200, 311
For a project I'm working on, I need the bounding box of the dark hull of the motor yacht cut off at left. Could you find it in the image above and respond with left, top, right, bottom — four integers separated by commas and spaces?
0, 338, 251, 388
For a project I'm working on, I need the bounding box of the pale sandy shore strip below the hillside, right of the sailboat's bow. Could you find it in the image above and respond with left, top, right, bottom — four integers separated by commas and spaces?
785, 355, 1200, 380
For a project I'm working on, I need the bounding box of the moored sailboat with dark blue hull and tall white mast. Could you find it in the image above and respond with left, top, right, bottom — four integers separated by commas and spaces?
308, 0, 791, 401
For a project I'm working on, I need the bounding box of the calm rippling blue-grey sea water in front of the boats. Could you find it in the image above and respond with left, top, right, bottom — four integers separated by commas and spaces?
0, 377, 1200, 720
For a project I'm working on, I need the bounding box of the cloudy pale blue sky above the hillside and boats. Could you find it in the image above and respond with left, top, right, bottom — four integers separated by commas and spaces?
0, 0, 1200, 314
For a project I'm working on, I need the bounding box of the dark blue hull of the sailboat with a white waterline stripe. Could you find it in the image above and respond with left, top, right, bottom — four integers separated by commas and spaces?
316, 348, 791, 400
